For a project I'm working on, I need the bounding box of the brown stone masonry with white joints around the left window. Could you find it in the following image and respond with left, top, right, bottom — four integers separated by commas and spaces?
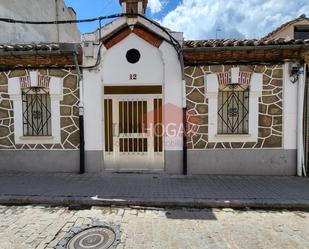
0, 69, 80, 150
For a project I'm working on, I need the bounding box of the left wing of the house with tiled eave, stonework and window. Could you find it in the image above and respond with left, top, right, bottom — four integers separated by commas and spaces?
0, 43, 82, 172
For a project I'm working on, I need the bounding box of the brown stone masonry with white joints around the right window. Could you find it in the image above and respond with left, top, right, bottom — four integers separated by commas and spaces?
185, 64, 283, 149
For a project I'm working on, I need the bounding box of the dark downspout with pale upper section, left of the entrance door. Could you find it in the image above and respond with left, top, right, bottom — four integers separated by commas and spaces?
74, 53, 85, 174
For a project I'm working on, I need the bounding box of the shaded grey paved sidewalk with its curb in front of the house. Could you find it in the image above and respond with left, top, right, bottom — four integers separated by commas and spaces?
0, 174, 309, 208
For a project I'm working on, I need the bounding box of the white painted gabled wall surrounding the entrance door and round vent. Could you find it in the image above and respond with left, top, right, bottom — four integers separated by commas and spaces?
83, 28, 183, 151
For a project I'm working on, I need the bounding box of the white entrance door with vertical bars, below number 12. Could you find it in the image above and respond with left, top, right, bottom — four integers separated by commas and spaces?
104, 95, 164, 171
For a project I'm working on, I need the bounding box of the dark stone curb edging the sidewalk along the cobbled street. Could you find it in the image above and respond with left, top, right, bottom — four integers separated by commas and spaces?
0, 195, 309, 209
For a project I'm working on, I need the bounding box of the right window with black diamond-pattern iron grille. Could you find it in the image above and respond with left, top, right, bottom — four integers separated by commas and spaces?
218, 84, 249, 134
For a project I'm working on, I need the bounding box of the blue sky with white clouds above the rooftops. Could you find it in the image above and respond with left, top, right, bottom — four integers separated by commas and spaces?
65, 0, 309, 40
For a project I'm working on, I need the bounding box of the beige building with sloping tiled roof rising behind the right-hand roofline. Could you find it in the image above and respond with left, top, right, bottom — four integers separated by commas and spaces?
264, 15, 309, 40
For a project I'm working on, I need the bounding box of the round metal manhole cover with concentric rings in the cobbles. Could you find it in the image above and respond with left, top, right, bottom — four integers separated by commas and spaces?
67, 227, 116, 249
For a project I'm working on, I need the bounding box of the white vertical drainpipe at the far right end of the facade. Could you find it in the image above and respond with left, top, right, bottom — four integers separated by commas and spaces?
297, 66, 305, 176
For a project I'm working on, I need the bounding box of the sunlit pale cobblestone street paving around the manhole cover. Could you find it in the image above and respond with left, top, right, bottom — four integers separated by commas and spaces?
0, 206, 309, 249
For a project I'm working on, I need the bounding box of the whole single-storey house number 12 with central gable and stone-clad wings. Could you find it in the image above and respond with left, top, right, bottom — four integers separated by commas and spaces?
0, 0, 309, 175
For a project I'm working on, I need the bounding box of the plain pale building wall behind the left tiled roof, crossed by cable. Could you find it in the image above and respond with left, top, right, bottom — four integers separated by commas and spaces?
0, 0, 80, 43
